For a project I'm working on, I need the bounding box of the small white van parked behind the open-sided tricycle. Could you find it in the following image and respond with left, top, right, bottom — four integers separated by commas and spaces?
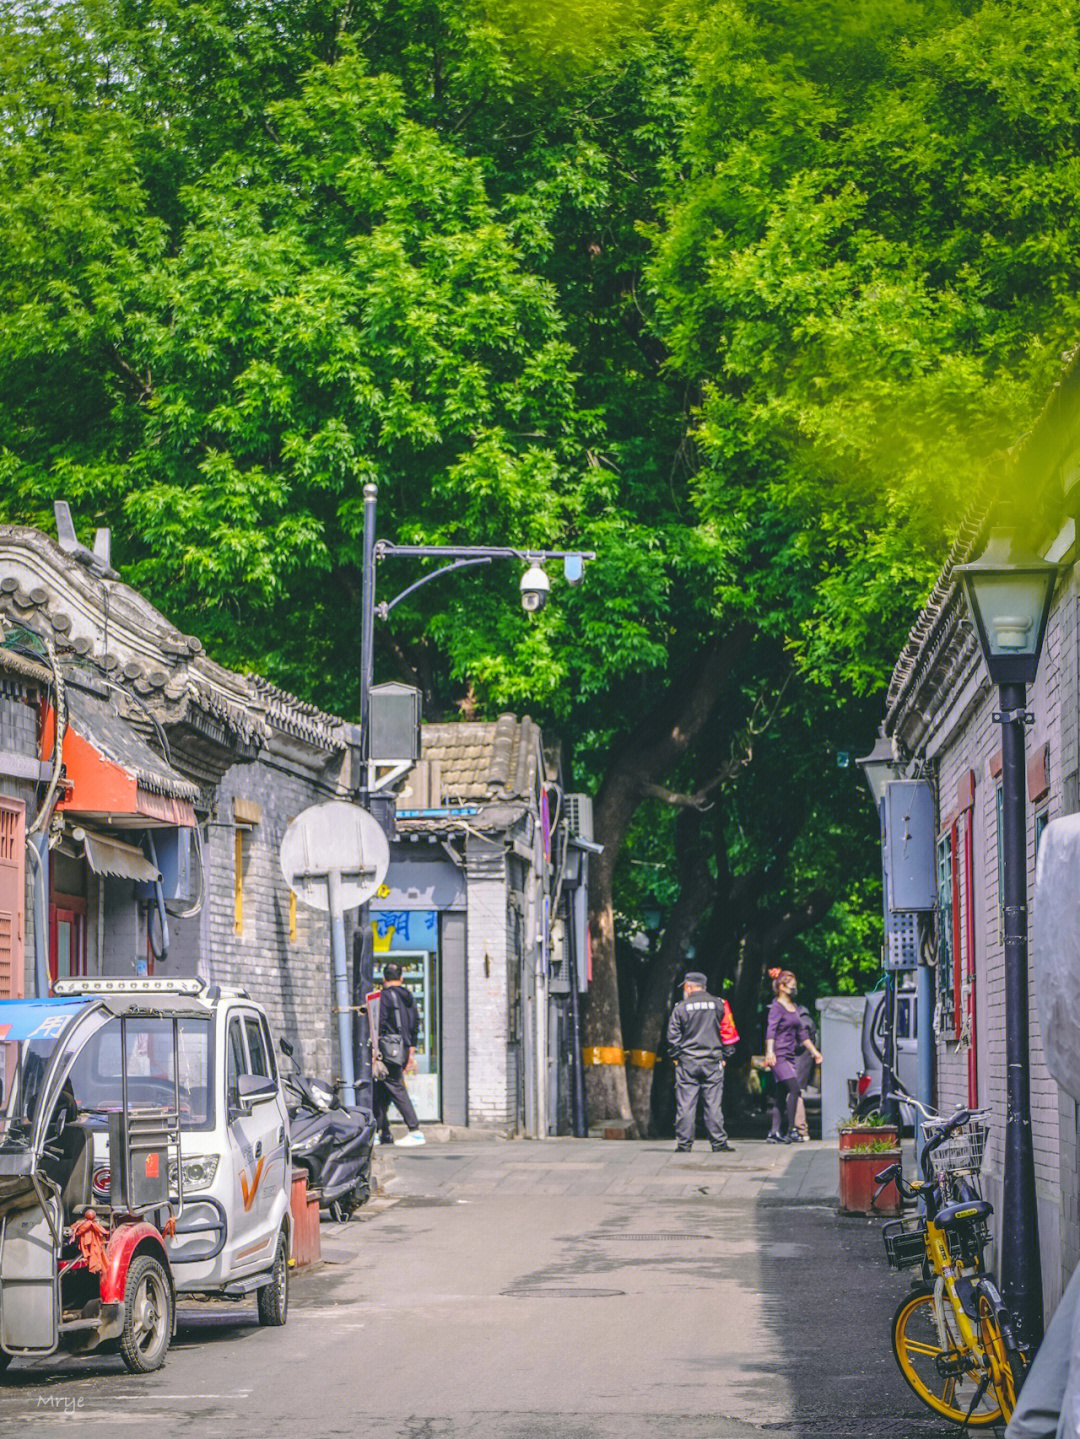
53, 976, 292, 1324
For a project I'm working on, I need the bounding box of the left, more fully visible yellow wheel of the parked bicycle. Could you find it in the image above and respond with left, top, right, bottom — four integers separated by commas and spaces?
893, 1289, 1001, 1427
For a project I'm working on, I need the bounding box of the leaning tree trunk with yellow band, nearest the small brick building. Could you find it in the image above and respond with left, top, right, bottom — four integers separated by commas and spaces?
585, 627, 751, 1124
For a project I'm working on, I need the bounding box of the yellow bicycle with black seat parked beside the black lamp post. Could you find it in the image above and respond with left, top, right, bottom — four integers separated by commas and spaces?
874, 1107, 1024, 1427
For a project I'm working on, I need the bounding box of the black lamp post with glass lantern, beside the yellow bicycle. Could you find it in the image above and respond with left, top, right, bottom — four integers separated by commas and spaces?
955, 530, 1057, 1345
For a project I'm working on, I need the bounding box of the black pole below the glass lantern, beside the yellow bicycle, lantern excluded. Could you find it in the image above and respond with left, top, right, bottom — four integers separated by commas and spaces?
998, 685, 1043, 1345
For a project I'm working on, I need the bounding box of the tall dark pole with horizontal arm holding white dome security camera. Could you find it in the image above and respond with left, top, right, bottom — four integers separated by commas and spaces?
354, 481, 595, 1108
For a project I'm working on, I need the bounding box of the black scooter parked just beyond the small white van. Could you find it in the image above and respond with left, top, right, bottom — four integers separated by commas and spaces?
280, 1039, 375, 1220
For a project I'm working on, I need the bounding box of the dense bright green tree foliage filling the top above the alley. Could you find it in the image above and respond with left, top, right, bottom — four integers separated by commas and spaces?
0, 0, 1080, 1018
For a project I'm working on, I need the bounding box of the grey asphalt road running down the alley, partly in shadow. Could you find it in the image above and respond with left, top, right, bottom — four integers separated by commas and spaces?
0, 1141, 977, 1439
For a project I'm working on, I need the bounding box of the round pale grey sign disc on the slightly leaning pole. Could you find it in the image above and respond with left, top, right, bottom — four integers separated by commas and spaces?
280, 800, 390, 912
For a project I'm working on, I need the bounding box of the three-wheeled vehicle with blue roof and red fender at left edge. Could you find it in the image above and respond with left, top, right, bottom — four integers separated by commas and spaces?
0, 996, 183, 1373
